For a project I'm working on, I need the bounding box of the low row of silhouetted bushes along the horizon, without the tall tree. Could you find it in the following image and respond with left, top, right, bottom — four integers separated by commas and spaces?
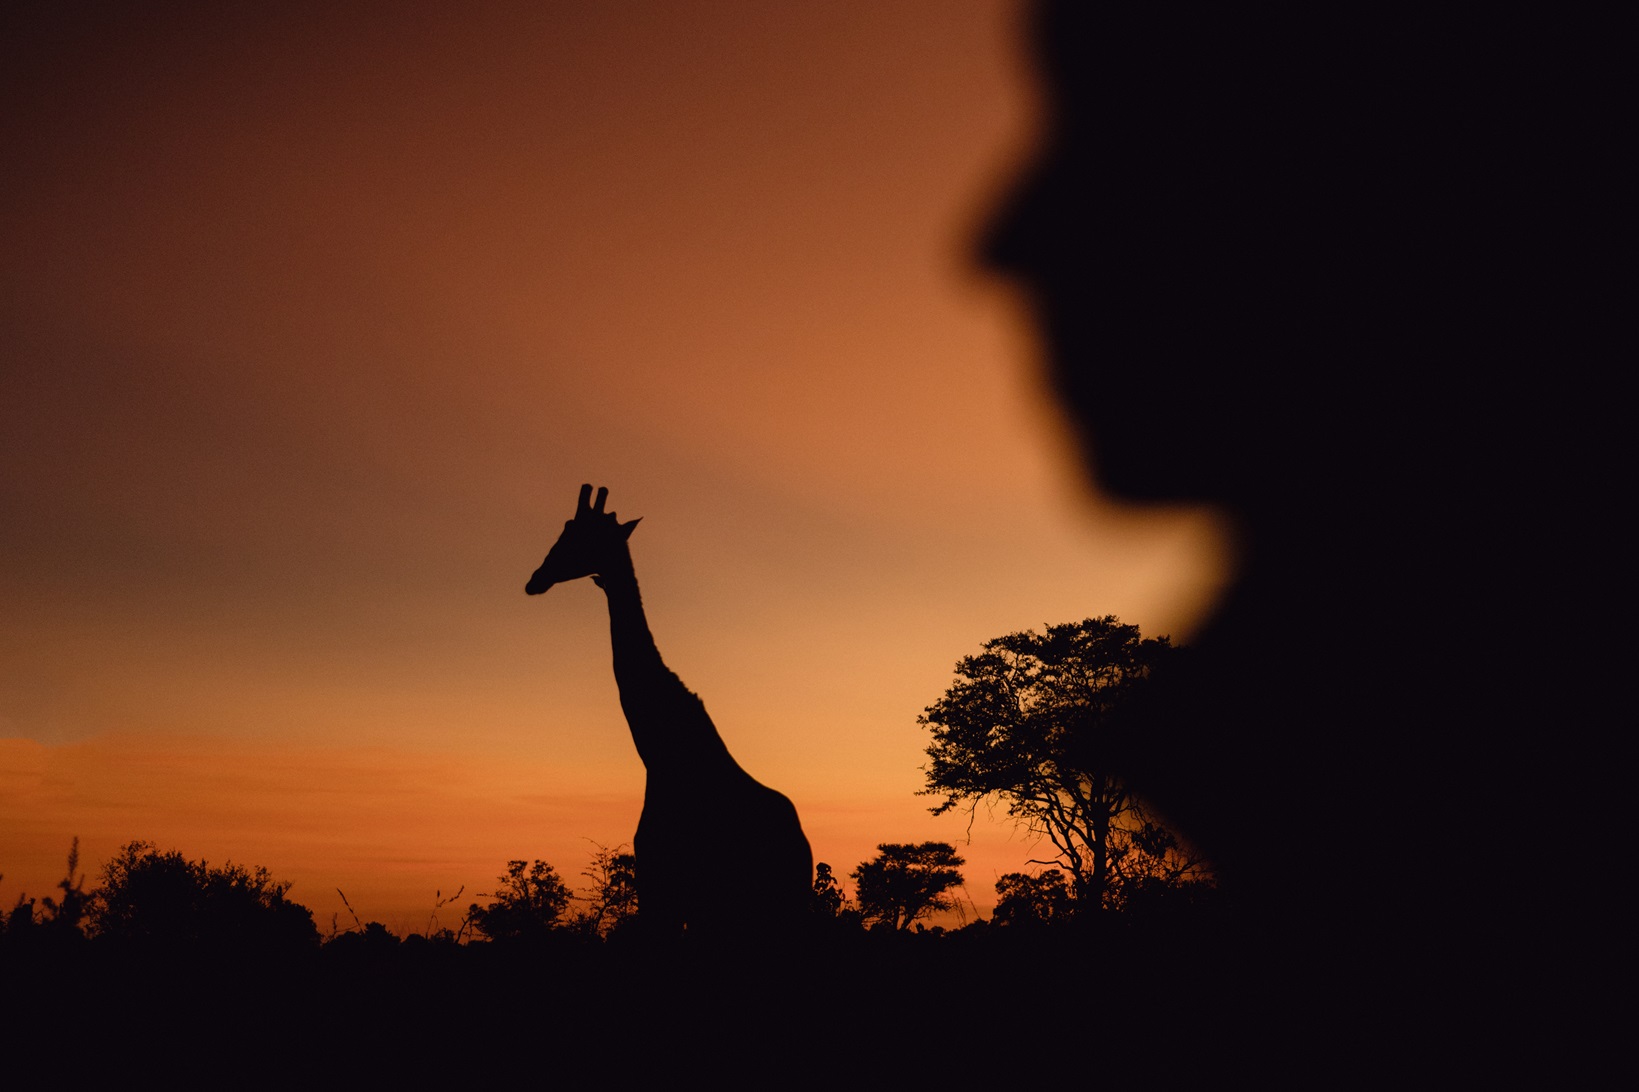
0, 829, 1216, 953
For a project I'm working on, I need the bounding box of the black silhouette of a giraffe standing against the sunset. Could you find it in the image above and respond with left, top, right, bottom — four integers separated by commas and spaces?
524, 485, 813, 936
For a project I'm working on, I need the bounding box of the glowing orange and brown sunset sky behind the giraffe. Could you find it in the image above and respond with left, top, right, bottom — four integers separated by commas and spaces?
0, 0, 1223, 930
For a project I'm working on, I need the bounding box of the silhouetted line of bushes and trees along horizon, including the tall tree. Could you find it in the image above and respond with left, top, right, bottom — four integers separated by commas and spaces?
3, 615, 1218, 949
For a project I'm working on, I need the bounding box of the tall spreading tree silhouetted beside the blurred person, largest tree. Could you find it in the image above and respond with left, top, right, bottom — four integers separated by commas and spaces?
918, 615, 1201, 907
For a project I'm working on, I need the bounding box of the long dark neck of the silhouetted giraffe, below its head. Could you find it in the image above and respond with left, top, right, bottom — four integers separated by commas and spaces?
598, 549, 734, 770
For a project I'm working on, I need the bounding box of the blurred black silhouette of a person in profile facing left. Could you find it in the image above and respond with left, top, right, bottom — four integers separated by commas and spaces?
983, 2, 1613, 983
